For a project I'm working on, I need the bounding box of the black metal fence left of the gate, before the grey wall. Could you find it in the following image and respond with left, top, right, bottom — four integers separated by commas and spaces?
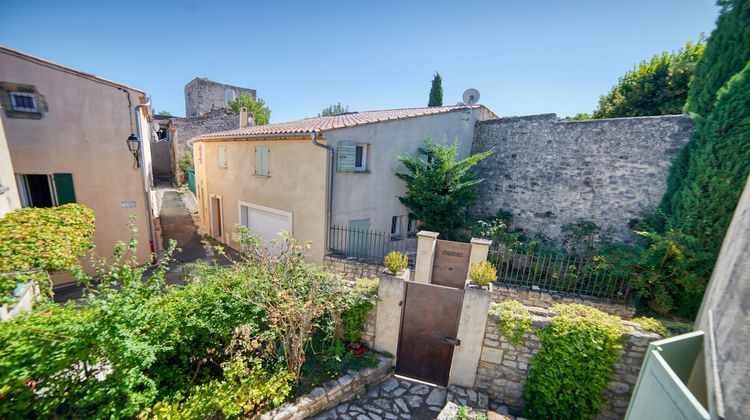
328, 226, 417, 268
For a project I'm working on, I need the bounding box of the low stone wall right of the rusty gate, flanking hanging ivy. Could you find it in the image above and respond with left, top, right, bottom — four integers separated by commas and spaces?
474, 310, 661, 419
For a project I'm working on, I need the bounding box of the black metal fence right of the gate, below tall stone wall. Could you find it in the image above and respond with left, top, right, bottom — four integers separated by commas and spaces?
487, 244, 631, 301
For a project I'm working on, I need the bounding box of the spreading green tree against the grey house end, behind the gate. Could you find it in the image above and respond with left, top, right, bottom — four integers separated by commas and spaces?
396, 139, 493, 239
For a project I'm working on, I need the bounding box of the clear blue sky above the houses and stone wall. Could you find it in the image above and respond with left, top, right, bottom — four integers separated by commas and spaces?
0, 0, 718, 122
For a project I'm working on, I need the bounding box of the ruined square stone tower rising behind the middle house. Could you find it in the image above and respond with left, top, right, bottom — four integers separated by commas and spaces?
185, 77, 256, 118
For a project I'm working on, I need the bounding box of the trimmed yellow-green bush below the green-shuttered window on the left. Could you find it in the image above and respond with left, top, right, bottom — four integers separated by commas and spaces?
0, 204, 95, 304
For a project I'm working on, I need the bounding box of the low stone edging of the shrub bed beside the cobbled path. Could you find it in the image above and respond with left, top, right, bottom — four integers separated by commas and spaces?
258, 357, 393, 420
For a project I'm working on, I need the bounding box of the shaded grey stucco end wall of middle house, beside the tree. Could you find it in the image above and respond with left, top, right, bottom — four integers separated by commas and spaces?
325, 107, 492, 232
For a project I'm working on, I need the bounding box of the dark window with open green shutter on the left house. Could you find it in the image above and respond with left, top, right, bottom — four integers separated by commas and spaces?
16, 174, 76, 207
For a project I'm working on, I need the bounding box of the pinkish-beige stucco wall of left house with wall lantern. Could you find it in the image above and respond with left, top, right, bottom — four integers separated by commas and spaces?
0, 49, 156, 282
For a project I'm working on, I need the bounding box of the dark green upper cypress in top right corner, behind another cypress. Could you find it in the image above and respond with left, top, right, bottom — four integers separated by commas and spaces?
685, 0, 750, 116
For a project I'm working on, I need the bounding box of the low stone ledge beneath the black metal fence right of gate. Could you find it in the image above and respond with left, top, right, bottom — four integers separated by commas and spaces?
492, 283, 635, 319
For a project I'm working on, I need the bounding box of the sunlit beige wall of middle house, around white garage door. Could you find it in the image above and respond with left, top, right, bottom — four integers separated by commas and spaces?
193, 138, 327, 263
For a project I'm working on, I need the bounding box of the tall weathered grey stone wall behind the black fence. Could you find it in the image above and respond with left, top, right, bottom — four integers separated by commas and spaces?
472, 114, 693, 241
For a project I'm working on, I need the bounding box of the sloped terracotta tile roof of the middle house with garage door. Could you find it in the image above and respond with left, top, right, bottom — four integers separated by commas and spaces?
195, 105, 494, 140
